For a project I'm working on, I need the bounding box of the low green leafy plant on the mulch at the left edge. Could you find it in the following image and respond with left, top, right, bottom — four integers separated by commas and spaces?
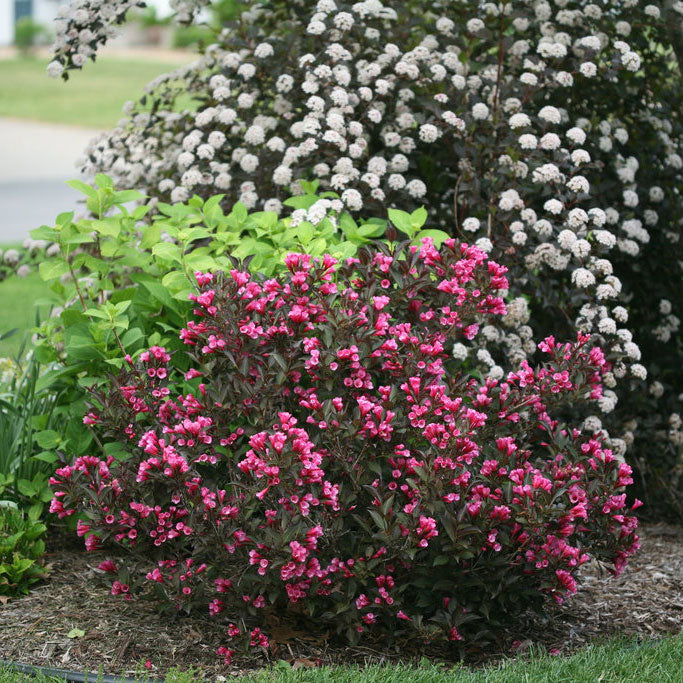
0, 504, 47, 595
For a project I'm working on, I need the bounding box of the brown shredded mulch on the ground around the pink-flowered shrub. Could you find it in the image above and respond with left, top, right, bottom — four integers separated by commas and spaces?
0, 525, 683, 680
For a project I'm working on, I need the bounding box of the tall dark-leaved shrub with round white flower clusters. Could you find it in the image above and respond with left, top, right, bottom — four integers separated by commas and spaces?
48, 0, 683, 512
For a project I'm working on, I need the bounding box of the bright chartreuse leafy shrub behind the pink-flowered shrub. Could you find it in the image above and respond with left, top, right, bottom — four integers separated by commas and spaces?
24, 175, 447, 496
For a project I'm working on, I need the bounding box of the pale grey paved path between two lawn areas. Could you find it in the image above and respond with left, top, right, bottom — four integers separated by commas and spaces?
0, 117, 97, 244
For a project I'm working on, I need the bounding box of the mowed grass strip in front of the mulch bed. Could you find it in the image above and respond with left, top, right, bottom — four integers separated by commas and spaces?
0, 635, 683, 683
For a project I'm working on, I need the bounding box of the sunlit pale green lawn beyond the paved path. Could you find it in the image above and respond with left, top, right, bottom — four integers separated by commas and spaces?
0, 53, 195, 129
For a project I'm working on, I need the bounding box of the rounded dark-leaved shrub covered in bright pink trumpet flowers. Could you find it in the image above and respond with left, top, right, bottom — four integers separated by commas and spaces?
51, 239, 638, 661
